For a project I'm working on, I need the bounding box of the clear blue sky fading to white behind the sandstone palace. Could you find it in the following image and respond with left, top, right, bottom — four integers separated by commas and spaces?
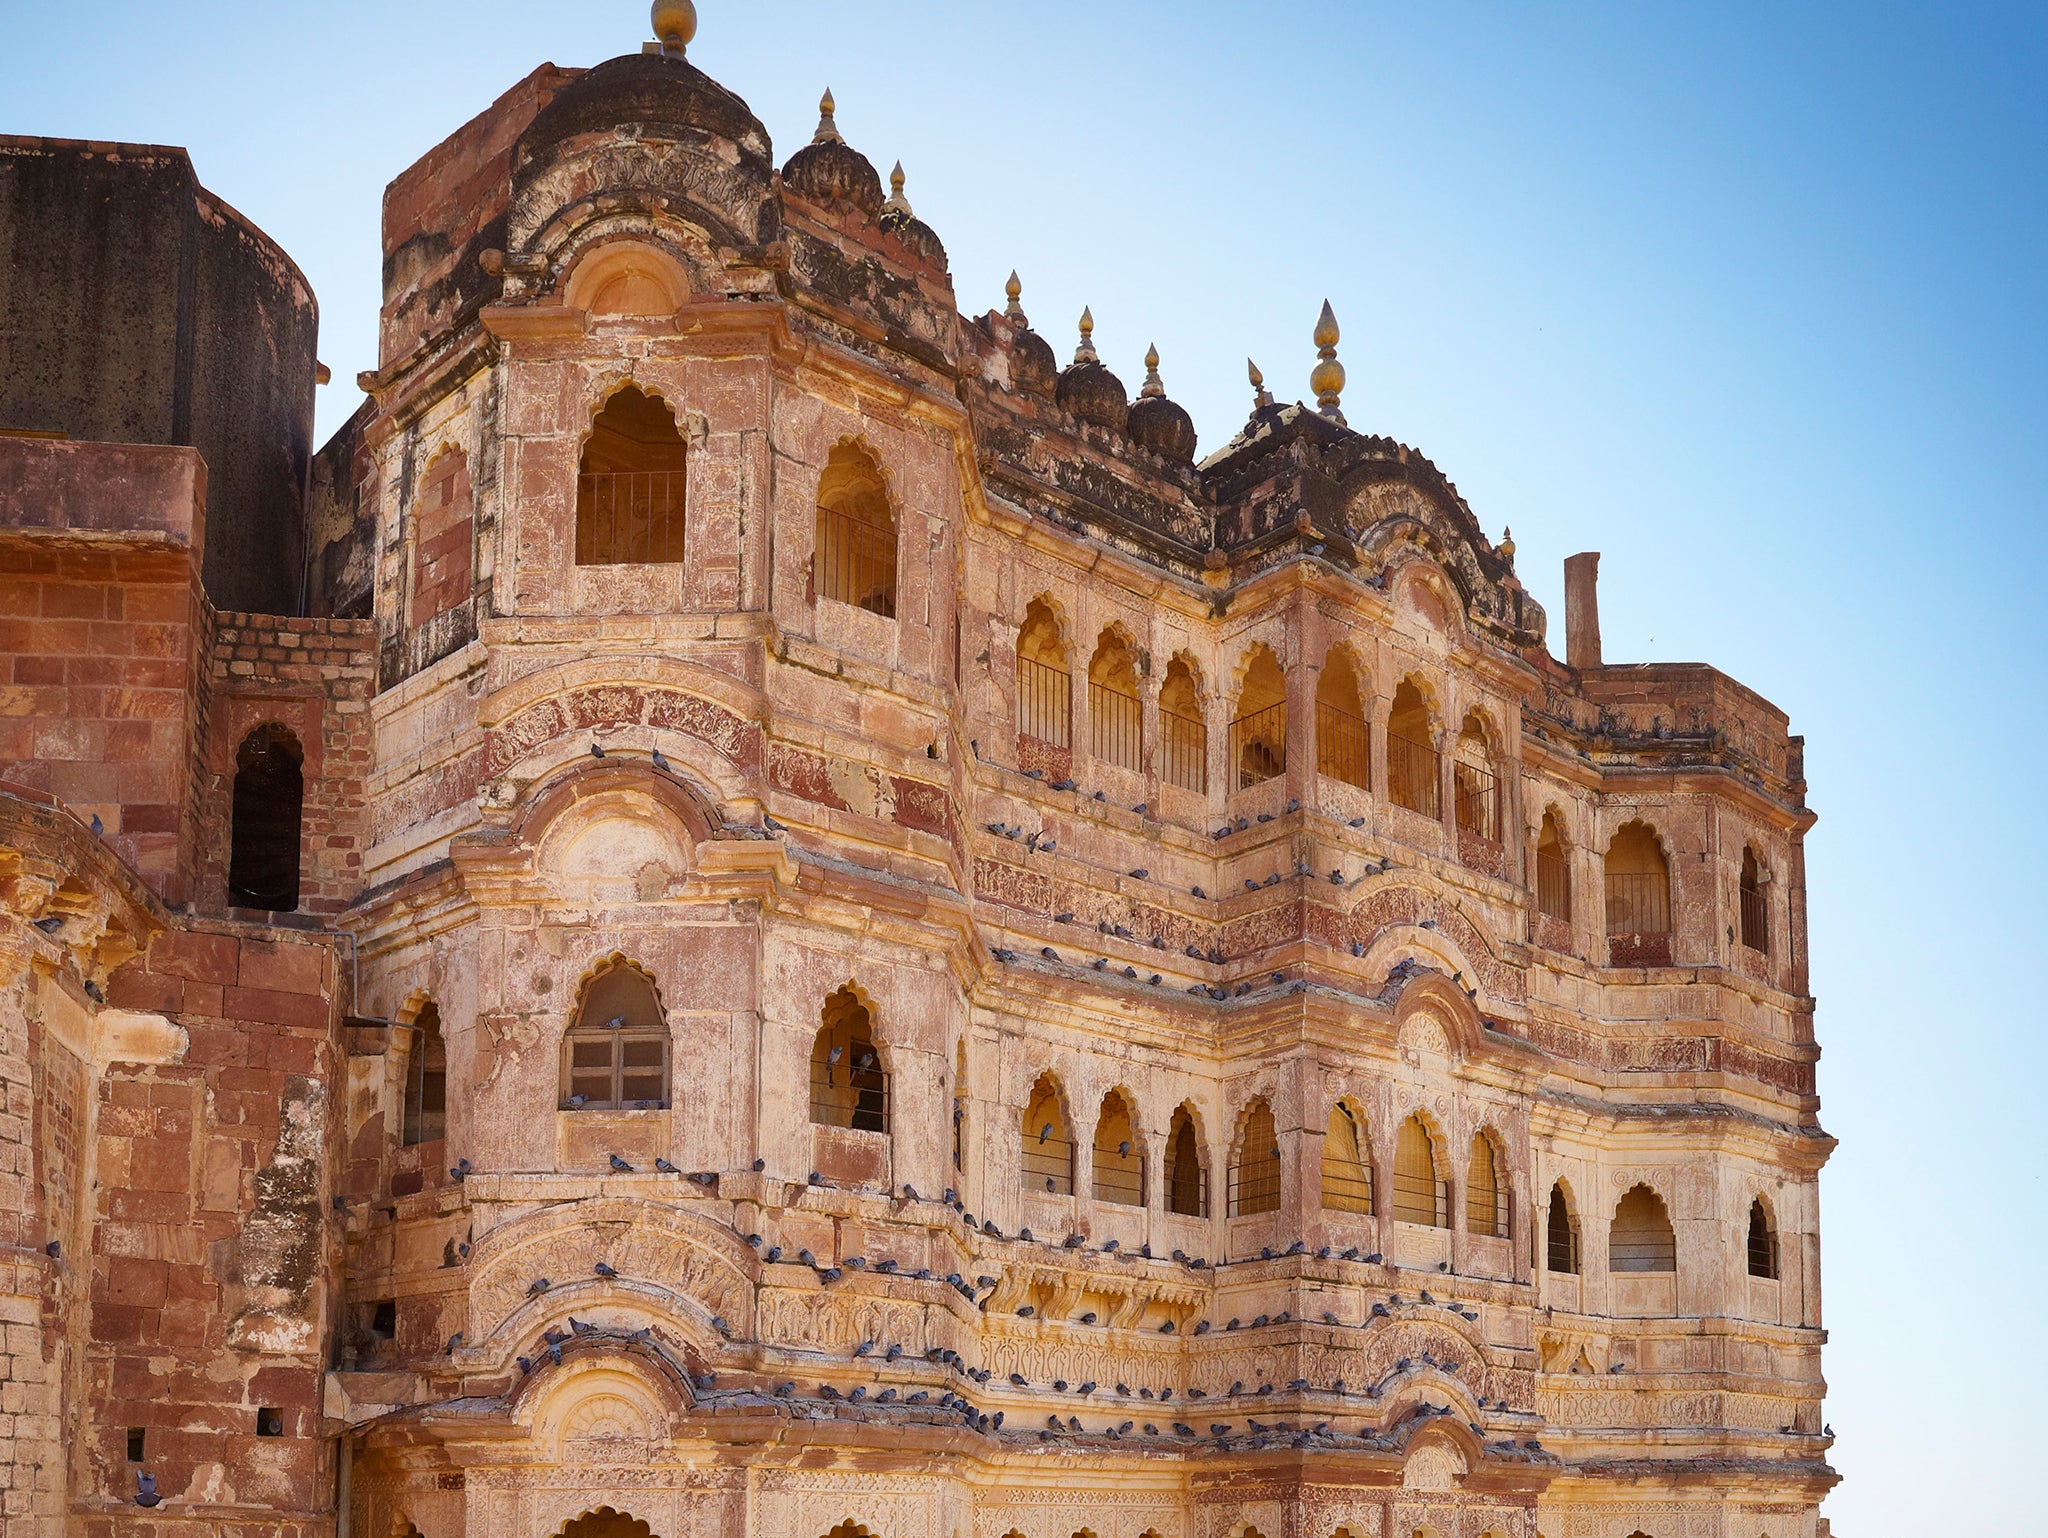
0, 0, 2048, 1538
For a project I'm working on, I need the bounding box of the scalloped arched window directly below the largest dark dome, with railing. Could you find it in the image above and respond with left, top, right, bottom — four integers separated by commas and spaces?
575, 385, 684, 565
